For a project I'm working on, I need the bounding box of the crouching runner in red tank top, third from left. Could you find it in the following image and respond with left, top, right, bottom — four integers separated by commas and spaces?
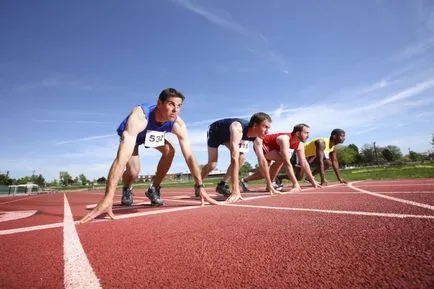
241, 123, 320, 192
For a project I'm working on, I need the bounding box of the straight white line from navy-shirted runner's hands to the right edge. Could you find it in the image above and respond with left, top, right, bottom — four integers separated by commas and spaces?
226, 204, 434, 219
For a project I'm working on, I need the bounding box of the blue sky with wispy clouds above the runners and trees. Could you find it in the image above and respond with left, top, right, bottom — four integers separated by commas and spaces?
0, 0, 434, 180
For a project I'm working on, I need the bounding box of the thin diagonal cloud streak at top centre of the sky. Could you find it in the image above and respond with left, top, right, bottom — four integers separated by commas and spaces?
172, 0, 289, 74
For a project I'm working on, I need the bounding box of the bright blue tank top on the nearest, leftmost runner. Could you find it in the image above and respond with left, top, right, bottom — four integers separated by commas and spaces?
117, 103, 176, 145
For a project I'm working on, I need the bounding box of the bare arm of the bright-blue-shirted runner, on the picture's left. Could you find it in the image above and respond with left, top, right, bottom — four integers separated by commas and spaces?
80, 107, 147, 223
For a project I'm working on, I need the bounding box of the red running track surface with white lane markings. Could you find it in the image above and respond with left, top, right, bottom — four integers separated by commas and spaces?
0, 179, 434, 288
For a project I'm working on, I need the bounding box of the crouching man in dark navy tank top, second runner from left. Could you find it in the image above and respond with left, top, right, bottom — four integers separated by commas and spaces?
199, 112, 271, 202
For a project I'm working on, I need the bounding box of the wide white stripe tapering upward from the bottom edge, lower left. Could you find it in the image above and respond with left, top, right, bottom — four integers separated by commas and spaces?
63, 194, 101, 289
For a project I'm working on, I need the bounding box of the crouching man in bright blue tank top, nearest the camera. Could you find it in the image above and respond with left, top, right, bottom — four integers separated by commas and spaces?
80, 88, 219, 223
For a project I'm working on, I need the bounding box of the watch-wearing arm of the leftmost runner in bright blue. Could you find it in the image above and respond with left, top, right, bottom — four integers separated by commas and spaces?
172, 117, 220, 205
